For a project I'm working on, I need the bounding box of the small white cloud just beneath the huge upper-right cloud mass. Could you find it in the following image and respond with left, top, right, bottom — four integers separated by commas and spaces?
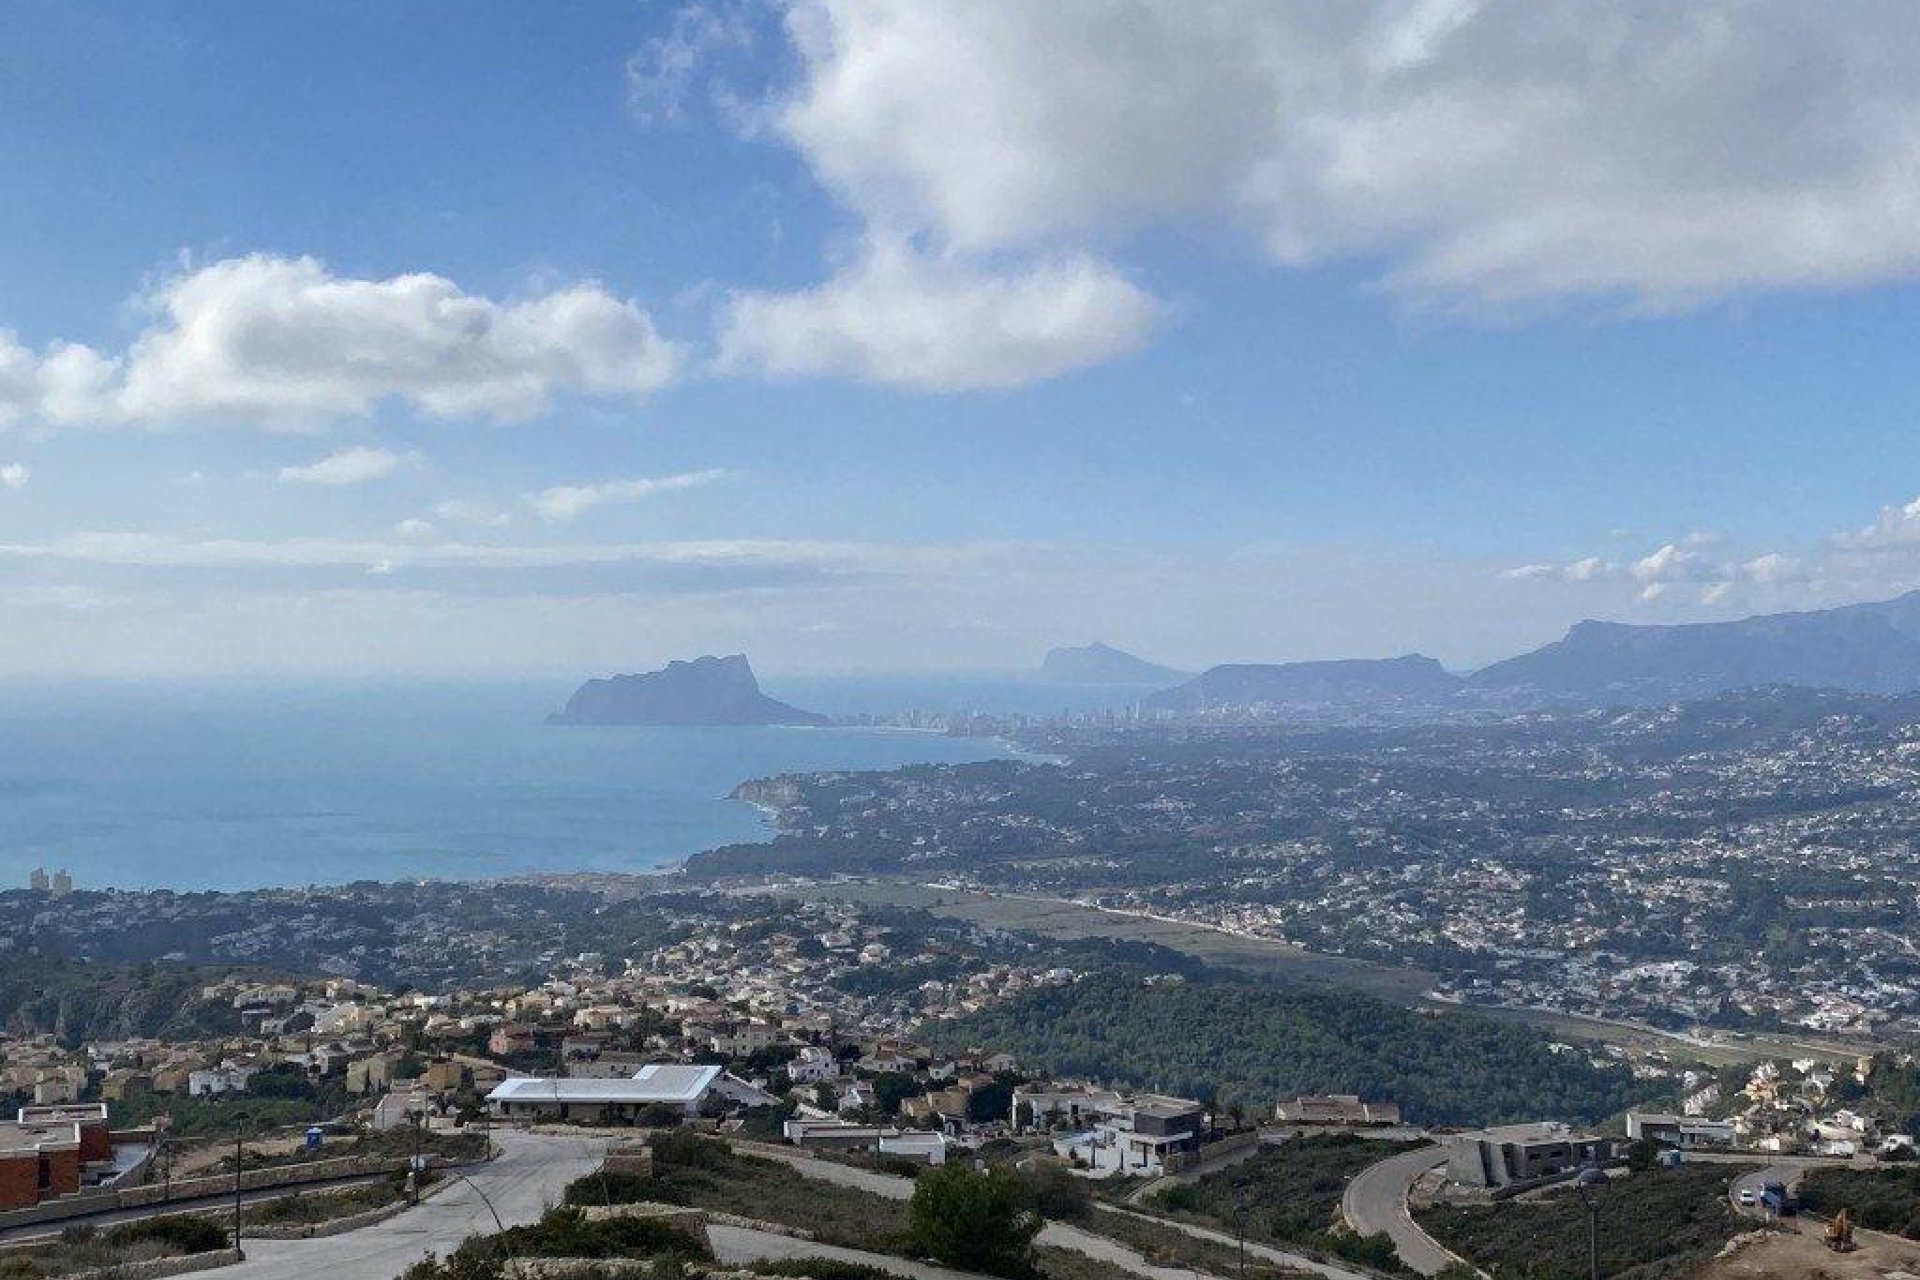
720, 242, 1158, 391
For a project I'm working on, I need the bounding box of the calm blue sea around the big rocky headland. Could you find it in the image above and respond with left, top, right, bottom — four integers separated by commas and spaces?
0, 677, 1139, 890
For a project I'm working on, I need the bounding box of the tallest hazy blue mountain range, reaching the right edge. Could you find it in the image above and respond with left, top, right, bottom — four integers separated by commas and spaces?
1467, 591, 1920, 702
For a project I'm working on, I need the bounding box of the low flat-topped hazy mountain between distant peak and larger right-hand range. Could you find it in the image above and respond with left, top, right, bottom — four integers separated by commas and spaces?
1140, 654, 1461, 716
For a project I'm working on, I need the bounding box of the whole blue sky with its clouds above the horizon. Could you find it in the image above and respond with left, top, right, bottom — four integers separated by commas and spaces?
0, 0, 1920, 677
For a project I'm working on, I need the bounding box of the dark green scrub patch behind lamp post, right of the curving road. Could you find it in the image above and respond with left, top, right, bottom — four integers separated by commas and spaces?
1419, 1165, 1751, 1280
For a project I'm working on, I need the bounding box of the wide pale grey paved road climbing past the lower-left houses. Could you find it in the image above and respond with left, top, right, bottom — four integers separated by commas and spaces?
219, 1130, 607, 1280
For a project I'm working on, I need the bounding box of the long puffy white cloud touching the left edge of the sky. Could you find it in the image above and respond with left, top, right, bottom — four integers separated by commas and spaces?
0, 253, 684, 426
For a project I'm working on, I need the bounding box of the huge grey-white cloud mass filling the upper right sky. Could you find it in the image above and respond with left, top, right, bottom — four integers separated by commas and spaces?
778, 0, 1920, 305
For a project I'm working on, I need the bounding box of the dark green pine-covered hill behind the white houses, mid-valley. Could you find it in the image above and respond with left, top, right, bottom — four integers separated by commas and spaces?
920, 975, 1636, 1125
